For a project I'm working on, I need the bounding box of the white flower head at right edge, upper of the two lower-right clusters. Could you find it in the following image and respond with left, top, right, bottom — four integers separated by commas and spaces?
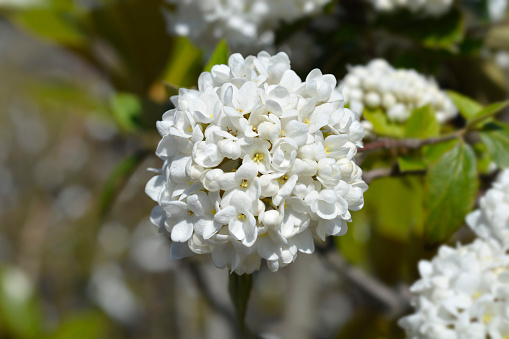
467, 169, 509, 249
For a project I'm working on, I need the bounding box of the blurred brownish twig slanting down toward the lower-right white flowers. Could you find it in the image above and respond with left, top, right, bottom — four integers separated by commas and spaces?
322, 250, 409, 317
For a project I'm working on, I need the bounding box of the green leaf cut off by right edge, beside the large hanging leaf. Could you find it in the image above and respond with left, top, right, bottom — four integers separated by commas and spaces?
480, 122, 509, 168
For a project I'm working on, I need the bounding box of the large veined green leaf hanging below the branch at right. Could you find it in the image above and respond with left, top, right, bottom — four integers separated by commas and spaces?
424, 142, 479, 245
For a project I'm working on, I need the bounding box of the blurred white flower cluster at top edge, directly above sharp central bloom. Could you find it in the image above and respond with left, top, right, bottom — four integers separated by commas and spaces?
168, 0, 330, 51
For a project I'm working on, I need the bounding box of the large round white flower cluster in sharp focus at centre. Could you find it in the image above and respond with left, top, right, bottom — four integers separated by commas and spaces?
146, 52, 367, 274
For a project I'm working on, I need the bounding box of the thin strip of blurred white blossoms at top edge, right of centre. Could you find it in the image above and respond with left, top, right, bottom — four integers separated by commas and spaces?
370, 0, 454, 16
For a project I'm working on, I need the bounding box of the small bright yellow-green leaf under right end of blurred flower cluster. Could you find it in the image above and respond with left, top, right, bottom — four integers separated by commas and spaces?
405, 105, 440, 139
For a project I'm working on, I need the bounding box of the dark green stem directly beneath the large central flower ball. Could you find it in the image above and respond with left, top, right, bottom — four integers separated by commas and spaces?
228, 273, 253, 329
